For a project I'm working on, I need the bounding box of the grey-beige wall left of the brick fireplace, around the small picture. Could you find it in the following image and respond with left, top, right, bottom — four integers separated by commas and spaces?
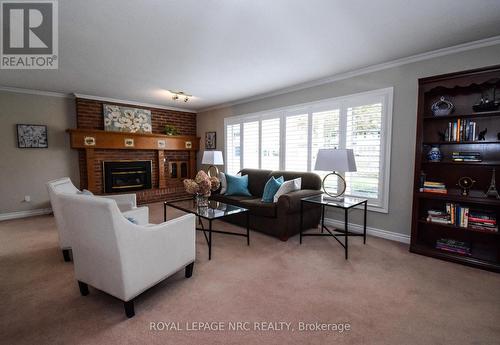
0, 91, 79, 216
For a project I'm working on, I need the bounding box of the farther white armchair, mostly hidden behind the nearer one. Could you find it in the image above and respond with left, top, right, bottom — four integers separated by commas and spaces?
47, 177, 149, 261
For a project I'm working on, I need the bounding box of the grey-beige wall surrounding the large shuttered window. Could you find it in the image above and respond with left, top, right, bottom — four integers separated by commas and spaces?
197, 45, 500, 235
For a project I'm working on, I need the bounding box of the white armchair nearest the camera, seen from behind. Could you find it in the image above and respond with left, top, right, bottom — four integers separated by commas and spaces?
60, 194, 196, 317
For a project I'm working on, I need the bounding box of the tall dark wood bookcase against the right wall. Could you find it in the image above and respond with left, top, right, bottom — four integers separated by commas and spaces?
410, 66, 500, 272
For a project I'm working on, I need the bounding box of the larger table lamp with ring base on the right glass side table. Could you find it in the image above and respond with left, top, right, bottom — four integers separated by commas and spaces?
314, 149, 356, 200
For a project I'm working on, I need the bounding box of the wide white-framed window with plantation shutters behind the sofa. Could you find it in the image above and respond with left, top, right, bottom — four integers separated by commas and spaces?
224, 88, 393, 212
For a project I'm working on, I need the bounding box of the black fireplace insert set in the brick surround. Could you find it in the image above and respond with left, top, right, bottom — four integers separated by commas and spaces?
102, 161, 151, 193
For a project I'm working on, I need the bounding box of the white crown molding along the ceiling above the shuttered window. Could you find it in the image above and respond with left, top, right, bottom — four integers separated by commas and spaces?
198, 36, 500, 113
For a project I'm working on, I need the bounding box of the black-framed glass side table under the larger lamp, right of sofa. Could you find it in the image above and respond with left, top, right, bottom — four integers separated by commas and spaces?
300, 194, 368, 260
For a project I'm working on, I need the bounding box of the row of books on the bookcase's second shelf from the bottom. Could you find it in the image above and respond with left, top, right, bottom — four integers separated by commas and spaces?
426, 203, 498, 232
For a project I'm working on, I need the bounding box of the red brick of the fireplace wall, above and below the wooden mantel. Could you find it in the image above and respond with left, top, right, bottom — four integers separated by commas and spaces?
76, 98, 196, 203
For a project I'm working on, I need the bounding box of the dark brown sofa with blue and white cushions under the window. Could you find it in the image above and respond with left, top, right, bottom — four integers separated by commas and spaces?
211, 169, 321, 241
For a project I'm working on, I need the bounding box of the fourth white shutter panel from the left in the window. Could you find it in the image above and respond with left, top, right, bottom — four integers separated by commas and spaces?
285, 114, 309, 171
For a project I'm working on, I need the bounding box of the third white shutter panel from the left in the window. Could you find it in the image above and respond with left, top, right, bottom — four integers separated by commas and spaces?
260, 117, 281, 170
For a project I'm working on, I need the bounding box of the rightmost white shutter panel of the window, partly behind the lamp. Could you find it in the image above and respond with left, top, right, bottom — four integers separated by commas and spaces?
345, 103, 382, 199
